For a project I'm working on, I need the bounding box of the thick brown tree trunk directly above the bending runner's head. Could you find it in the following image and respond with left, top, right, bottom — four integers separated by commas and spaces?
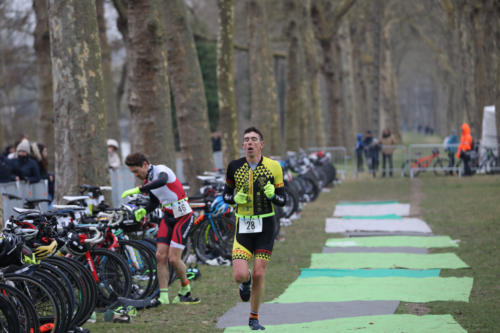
127, 0, 175, 167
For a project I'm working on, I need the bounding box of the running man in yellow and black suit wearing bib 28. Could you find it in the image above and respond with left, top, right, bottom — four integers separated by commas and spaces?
224, 127, 285, 330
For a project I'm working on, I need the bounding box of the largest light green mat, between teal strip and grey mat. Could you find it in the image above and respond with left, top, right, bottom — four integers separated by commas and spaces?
271, 277, 473, 303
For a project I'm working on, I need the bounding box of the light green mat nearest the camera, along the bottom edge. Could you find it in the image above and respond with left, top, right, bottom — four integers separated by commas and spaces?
224, 314, 467, 333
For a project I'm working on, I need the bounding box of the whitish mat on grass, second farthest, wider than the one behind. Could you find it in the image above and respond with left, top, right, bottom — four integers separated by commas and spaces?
325, 218, 432, 232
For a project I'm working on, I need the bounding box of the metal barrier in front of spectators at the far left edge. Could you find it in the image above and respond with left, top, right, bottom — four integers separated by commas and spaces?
0, 179, 49, 221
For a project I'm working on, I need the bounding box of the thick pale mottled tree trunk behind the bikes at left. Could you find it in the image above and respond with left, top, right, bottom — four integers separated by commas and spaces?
49, 0, 109, 202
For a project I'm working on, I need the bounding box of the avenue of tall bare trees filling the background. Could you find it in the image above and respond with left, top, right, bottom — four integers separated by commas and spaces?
0, 0, 500, 200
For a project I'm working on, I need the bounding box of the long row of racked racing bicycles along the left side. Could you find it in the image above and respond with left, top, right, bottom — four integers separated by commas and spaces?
0, 152, 335, 333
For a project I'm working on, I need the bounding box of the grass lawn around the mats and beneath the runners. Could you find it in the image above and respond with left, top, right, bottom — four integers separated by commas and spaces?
85, 174, 500, 333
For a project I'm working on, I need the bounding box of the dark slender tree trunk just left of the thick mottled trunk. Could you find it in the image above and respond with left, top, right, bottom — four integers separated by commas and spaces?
33, 0, 55, 170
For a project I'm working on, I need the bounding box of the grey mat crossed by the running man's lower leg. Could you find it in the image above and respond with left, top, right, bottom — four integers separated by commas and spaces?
217, 301, 399, 328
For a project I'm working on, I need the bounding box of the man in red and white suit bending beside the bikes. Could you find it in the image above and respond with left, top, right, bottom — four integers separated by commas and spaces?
122, 153, 200, 304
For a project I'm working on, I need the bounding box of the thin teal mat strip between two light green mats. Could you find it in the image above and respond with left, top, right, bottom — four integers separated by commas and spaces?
299, 268, 441, 279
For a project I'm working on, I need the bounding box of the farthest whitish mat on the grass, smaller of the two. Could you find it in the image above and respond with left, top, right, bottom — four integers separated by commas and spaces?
333, 203, 410, 216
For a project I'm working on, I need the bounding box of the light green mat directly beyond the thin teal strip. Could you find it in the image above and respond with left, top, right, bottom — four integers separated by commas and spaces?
310, 252, 469, 269
